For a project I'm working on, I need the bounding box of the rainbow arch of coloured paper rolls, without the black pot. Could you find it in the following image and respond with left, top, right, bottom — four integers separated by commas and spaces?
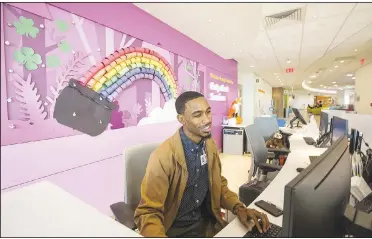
79, 47, 177, 102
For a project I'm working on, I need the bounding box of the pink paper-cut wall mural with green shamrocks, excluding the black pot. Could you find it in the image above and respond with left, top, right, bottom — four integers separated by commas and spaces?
1, 4, 235, 145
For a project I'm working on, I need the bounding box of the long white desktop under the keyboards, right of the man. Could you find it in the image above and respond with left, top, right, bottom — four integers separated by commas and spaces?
216, 121, 326, 237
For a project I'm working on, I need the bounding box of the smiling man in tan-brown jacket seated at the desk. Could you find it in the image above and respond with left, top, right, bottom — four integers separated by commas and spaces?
134, 91, 269, 237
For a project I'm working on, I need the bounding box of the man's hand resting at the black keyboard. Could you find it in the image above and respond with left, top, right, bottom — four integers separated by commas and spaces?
236, 207, 270, 233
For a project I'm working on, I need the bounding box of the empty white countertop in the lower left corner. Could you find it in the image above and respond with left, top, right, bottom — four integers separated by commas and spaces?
1, 181, 140, 237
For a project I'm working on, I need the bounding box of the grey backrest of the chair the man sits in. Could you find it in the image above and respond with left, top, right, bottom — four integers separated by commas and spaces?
124, 143, 160, 204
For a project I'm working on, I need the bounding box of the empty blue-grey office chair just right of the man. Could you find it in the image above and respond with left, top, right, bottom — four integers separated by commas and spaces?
239, 124, 288, 206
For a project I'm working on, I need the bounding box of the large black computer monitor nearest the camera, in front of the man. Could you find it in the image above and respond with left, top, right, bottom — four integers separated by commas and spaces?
281, 137, 351, 238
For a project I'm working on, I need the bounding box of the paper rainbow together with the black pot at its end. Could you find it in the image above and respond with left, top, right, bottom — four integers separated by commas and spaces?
53, 47, 178, 136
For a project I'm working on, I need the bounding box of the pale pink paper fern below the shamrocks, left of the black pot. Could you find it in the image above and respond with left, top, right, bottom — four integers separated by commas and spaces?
12, 73, 47, 124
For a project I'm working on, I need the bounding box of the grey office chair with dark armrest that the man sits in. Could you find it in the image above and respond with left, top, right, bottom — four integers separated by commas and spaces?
110, 143, 160, 230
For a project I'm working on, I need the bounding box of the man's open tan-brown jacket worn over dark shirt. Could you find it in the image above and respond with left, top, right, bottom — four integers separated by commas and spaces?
134, 131, 241, 237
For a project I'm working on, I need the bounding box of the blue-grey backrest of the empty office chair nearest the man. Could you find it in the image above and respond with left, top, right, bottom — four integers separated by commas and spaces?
245, 124, 268, 181
